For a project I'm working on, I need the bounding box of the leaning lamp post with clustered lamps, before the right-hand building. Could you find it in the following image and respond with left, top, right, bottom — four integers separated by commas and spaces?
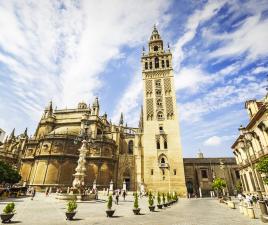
239, 125, 268, 223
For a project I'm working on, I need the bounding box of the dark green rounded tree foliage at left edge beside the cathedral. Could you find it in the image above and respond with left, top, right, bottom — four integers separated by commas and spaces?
0, 161, 21, 184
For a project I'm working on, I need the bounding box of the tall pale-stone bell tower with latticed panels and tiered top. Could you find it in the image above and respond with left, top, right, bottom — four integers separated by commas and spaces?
141, 26, 186, 194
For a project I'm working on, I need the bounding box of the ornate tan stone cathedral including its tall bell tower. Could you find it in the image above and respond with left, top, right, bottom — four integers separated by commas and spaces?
0, 27, 186, 195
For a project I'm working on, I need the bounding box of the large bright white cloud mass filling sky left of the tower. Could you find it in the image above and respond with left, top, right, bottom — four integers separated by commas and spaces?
0, 0, 170, 133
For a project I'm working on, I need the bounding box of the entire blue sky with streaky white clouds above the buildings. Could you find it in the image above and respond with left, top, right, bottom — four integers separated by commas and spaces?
0, 0, 268, 157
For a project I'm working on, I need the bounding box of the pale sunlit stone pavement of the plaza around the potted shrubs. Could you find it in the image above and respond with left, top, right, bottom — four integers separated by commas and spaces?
0, 193, 262, 225
